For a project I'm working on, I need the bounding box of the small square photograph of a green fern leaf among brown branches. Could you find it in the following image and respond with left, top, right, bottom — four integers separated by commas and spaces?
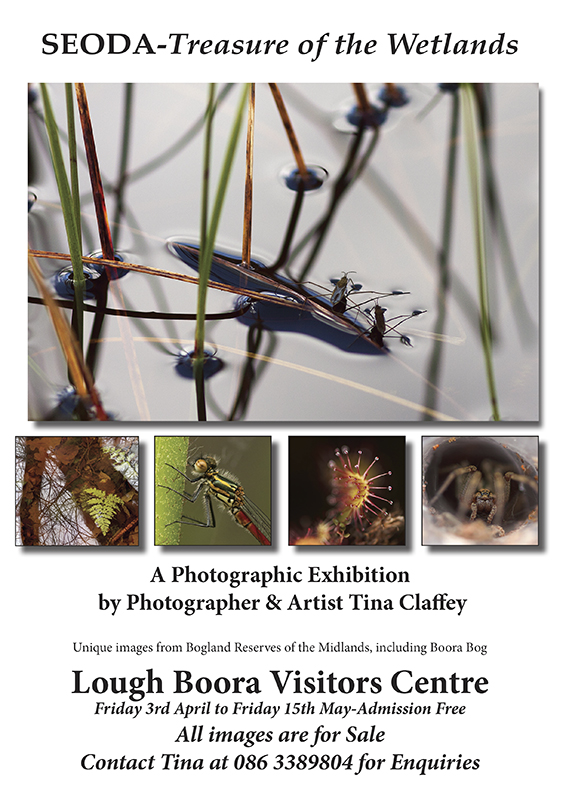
16, 436, 139, 547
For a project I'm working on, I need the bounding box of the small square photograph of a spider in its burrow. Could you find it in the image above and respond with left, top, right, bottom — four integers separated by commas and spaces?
422, 436, 538, 545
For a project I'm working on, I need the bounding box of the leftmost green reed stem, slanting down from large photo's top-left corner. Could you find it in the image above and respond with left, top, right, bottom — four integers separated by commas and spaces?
40, 83, 85, 349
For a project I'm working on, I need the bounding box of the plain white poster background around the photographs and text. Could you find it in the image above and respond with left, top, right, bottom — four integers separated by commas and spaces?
1, 0, 565, 800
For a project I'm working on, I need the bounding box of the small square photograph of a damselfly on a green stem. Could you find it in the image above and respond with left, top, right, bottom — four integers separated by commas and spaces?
155, 436, 271, 547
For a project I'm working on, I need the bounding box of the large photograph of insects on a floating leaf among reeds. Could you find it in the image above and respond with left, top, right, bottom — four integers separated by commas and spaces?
28, 83, 539, 424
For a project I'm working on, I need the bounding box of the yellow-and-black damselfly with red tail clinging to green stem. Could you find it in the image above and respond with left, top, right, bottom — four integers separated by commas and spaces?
160, 456, 271, 545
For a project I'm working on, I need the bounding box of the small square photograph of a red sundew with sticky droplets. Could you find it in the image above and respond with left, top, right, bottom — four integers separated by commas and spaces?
289, 436, 405, 546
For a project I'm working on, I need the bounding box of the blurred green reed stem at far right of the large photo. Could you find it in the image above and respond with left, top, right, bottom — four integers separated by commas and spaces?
461, 83, 501, 421
